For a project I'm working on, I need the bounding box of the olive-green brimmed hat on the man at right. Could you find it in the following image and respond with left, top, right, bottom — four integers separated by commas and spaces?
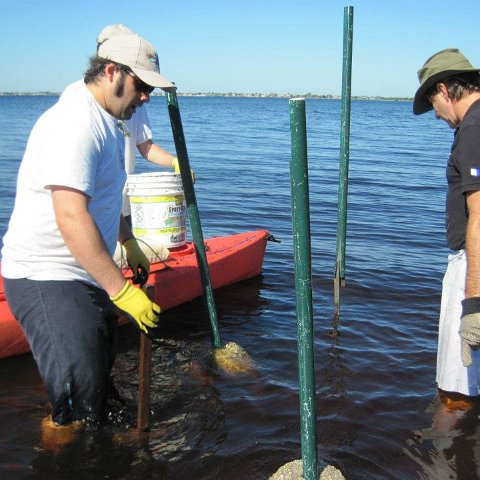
413, 48, 480, 115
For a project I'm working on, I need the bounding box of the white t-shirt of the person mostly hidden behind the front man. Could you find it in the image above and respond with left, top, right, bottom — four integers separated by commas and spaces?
60, 80, 152, 216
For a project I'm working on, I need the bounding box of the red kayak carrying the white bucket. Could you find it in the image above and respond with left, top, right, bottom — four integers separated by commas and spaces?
0, 230, 269, 358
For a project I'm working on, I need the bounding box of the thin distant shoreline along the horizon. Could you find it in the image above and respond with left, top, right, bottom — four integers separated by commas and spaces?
0, 92, 413, 102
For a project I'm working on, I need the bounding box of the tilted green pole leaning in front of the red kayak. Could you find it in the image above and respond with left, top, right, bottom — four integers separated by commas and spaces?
166, 92, 222, 348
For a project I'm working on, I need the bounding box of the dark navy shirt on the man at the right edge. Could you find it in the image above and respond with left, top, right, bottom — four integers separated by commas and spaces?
445, 100, 480, 250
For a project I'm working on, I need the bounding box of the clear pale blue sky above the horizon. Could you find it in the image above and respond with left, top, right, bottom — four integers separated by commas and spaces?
0, 0, 480, 97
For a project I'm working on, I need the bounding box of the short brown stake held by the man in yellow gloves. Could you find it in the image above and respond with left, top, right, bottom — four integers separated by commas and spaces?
137, 285, 155, 433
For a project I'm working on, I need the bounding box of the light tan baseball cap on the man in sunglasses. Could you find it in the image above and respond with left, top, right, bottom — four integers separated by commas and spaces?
98, 33, 175, 89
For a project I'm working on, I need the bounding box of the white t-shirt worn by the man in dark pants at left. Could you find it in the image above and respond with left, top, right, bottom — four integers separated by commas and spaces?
2, 85, 126, 285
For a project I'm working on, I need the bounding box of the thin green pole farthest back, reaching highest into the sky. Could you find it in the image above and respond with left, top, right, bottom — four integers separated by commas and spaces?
334, 7, 353, 319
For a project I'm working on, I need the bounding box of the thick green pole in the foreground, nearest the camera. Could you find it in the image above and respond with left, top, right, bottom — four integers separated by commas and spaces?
289, 98, 318, 480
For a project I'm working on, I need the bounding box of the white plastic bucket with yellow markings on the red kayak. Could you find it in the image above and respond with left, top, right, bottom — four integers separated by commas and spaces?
127, 172, 186, 249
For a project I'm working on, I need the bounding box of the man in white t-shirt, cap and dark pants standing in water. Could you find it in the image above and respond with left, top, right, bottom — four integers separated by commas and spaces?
2, 31, 174, 434
